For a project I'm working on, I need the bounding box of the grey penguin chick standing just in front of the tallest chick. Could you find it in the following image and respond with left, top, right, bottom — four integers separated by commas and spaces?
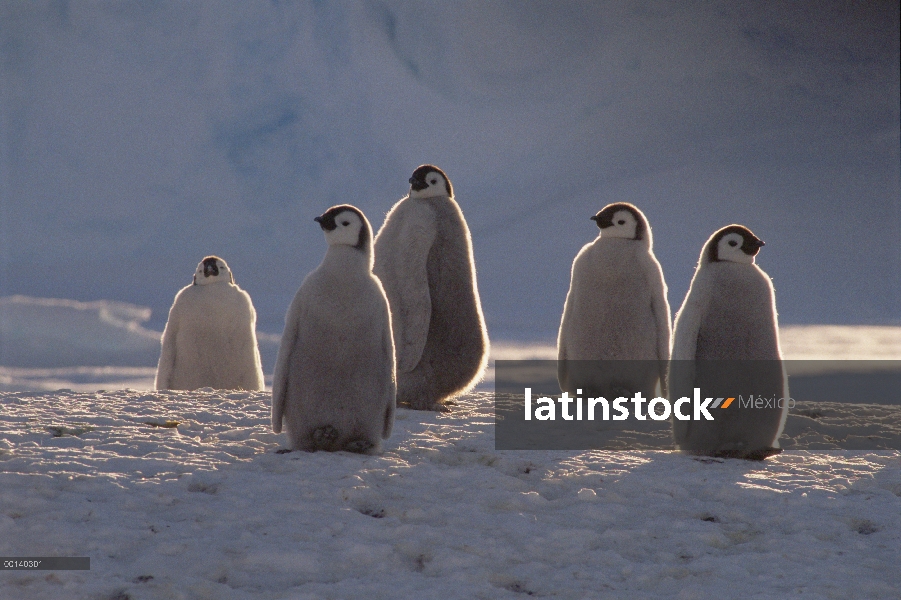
272, 204, 396, 454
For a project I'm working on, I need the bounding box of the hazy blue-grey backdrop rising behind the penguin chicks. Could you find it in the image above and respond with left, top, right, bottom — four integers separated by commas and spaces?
0, 1, 901, 339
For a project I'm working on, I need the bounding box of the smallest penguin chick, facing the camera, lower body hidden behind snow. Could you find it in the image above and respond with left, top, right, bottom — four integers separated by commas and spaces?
154, 256, 264, 390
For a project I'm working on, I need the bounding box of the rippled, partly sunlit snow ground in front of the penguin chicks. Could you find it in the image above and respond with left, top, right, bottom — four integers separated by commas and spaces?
0, 390, 901, 600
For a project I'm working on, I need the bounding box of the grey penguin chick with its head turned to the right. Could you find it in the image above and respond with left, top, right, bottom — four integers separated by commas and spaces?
668, 225, 788, 460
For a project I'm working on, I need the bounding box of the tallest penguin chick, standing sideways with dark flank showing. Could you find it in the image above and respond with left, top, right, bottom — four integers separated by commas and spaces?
374, 165, 488, 410
